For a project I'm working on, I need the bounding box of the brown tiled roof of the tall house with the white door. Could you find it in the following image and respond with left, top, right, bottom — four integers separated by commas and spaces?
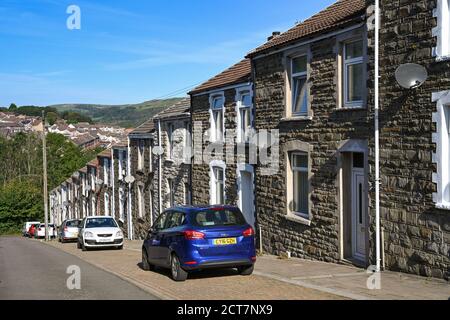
247, 0, 367, 57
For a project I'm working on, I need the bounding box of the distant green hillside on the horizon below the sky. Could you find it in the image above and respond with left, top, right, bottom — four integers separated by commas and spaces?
49, 98, 182, 128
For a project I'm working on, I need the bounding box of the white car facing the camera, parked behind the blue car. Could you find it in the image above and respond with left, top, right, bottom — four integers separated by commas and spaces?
77, 216, 123, 251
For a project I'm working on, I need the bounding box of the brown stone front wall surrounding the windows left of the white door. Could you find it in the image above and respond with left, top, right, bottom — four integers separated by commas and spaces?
252, 26, 371, 262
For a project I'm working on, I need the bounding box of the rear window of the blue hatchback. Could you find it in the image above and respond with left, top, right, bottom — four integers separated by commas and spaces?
191, 208, 246, 227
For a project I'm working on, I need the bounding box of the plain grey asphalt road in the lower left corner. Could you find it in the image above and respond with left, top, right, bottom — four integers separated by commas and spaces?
0, 237, 157, 300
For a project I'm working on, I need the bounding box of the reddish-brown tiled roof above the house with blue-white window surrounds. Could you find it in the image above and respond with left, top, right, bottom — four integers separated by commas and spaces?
189, 59, 251, 94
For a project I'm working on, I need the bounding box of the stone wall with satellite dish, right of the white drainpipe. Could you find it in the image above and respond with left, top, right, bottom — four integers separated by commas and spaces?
369, 0, 450, 279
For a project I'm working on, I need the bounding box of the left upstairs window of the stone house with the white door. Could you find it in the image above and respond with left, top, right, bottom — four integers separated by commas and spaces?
291, 55, 308, 116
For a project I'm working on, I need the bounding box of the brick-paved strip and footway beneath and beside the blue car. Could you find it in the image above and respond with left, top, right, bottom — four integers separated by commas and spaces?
41, 241, 450, 300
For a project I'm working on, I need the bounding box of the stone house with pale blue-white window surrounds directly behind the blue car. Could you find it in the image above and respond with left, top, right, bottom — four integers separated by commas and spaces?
189, 59, 255, 225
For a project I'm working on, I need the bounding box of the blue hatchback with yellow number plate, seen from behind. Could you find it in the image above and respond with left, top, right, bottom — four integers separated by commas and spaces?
142, 205, 256, 281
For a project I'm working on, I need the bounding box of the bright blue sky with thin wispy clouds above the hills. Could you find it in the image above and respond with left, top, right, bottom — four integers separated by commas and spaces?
0, 0, 334, 106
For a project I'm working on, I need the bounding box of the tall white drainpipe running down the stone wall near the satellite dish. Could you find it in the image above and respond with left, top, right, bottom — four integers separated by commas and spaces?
374, 0, 381, 272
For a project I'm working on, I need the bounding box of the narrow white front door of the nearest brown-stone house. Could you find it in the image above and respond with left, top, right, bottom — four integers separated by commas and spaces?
352, 168, 366, 261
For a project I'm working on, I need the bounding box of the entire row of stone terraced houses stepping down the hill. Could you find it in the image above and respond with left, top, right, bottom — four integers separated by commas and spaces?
51, 0, 450, 279
